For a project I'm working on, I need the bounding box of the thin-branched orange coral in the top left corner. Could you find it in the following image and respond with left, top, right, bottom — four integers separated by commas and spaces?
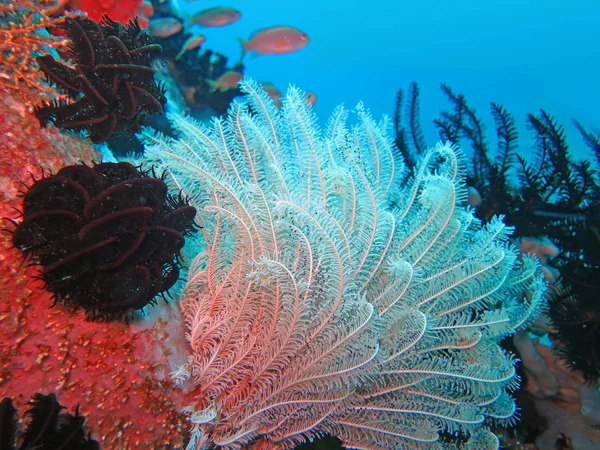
0, 0, 74, 98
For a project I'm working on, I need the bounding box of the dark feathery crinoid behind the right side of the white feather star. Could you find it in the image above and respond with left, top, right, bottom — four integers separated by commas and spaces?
396, 83, 600, 382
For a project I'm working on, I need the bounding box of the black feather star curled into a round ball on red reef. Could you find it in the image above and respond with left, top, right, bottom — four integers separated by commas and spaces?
12, 163, 196, 319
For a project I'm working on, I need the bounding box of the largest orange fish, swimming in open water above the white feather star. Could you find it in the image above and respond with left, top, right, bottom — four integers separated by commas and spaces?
238, 26, 308, 59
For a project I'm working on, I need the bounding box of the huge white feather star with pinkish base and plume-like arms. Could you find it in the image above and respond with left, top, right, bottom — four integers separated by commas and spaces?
146, 81, 546, 450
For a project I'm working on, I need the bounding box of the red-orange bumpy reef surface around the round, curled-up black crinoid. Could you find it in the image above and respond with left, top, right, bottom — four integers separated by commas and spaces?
0, 89, 188, 450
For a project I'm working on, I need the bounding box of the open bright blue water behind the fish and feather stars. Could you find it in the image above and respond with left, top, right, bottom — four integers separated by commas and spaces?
180, 0, 600, 156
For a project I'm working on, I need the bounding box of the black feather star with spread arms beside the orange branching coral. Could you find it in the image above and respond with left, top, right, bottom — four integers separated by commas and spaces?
35, 17, 166, 143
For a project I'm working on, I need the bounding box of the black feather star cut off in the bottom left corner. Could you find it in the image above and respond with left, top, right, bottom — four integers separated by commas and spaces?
0, 393, 100, 450
